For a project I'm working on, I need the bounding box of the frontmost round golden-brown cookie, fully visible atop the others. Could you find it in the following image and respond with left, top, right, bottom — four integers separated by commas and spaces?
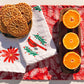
7, 16, 29, 37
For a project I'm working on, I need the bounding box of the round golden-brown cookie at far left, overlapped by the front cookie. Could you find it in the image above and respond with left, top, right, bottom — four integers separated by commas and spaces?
2, 7, 22, 26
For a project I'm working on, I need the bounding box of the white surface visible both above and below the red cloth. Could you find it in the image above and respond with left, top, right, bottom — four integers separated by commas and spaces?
0, 0, 84, 84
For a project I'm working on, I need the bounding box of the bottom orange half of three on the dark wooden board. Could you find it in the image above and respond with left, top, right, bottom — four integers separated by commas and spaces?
63, 52, 81, 70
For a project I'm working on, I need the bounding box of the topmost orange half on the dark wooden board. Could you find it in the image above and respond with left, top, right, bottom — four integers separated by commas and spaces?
63, 9, 80, 29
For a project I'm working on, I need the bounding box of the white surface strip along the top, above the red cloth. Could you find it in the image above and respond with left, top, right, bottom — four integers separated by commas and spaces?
0, 0, 84, 5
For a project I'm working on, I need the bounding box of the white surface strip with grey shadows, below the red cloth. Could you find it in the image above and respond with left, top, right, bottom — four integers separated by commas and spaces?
0, 80, 84, 84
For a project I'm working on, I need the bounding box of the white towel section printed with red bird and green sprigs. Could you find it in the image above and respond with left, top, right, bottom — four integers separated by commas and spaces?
19, 6, 57, 65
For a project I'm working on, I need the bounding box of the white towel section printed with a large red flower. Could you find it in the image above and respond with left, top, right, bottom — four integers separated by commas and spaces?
0, 33, 26, 73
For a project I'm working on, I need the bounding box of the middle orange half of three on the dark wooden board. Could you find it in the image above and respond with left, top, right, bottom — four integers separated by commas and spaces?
63, 32, 79, 50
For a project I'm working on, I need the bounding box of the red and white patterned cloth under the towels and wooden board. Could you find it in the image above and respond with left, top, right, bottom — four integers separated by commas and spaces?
0, 5, 84, 80
